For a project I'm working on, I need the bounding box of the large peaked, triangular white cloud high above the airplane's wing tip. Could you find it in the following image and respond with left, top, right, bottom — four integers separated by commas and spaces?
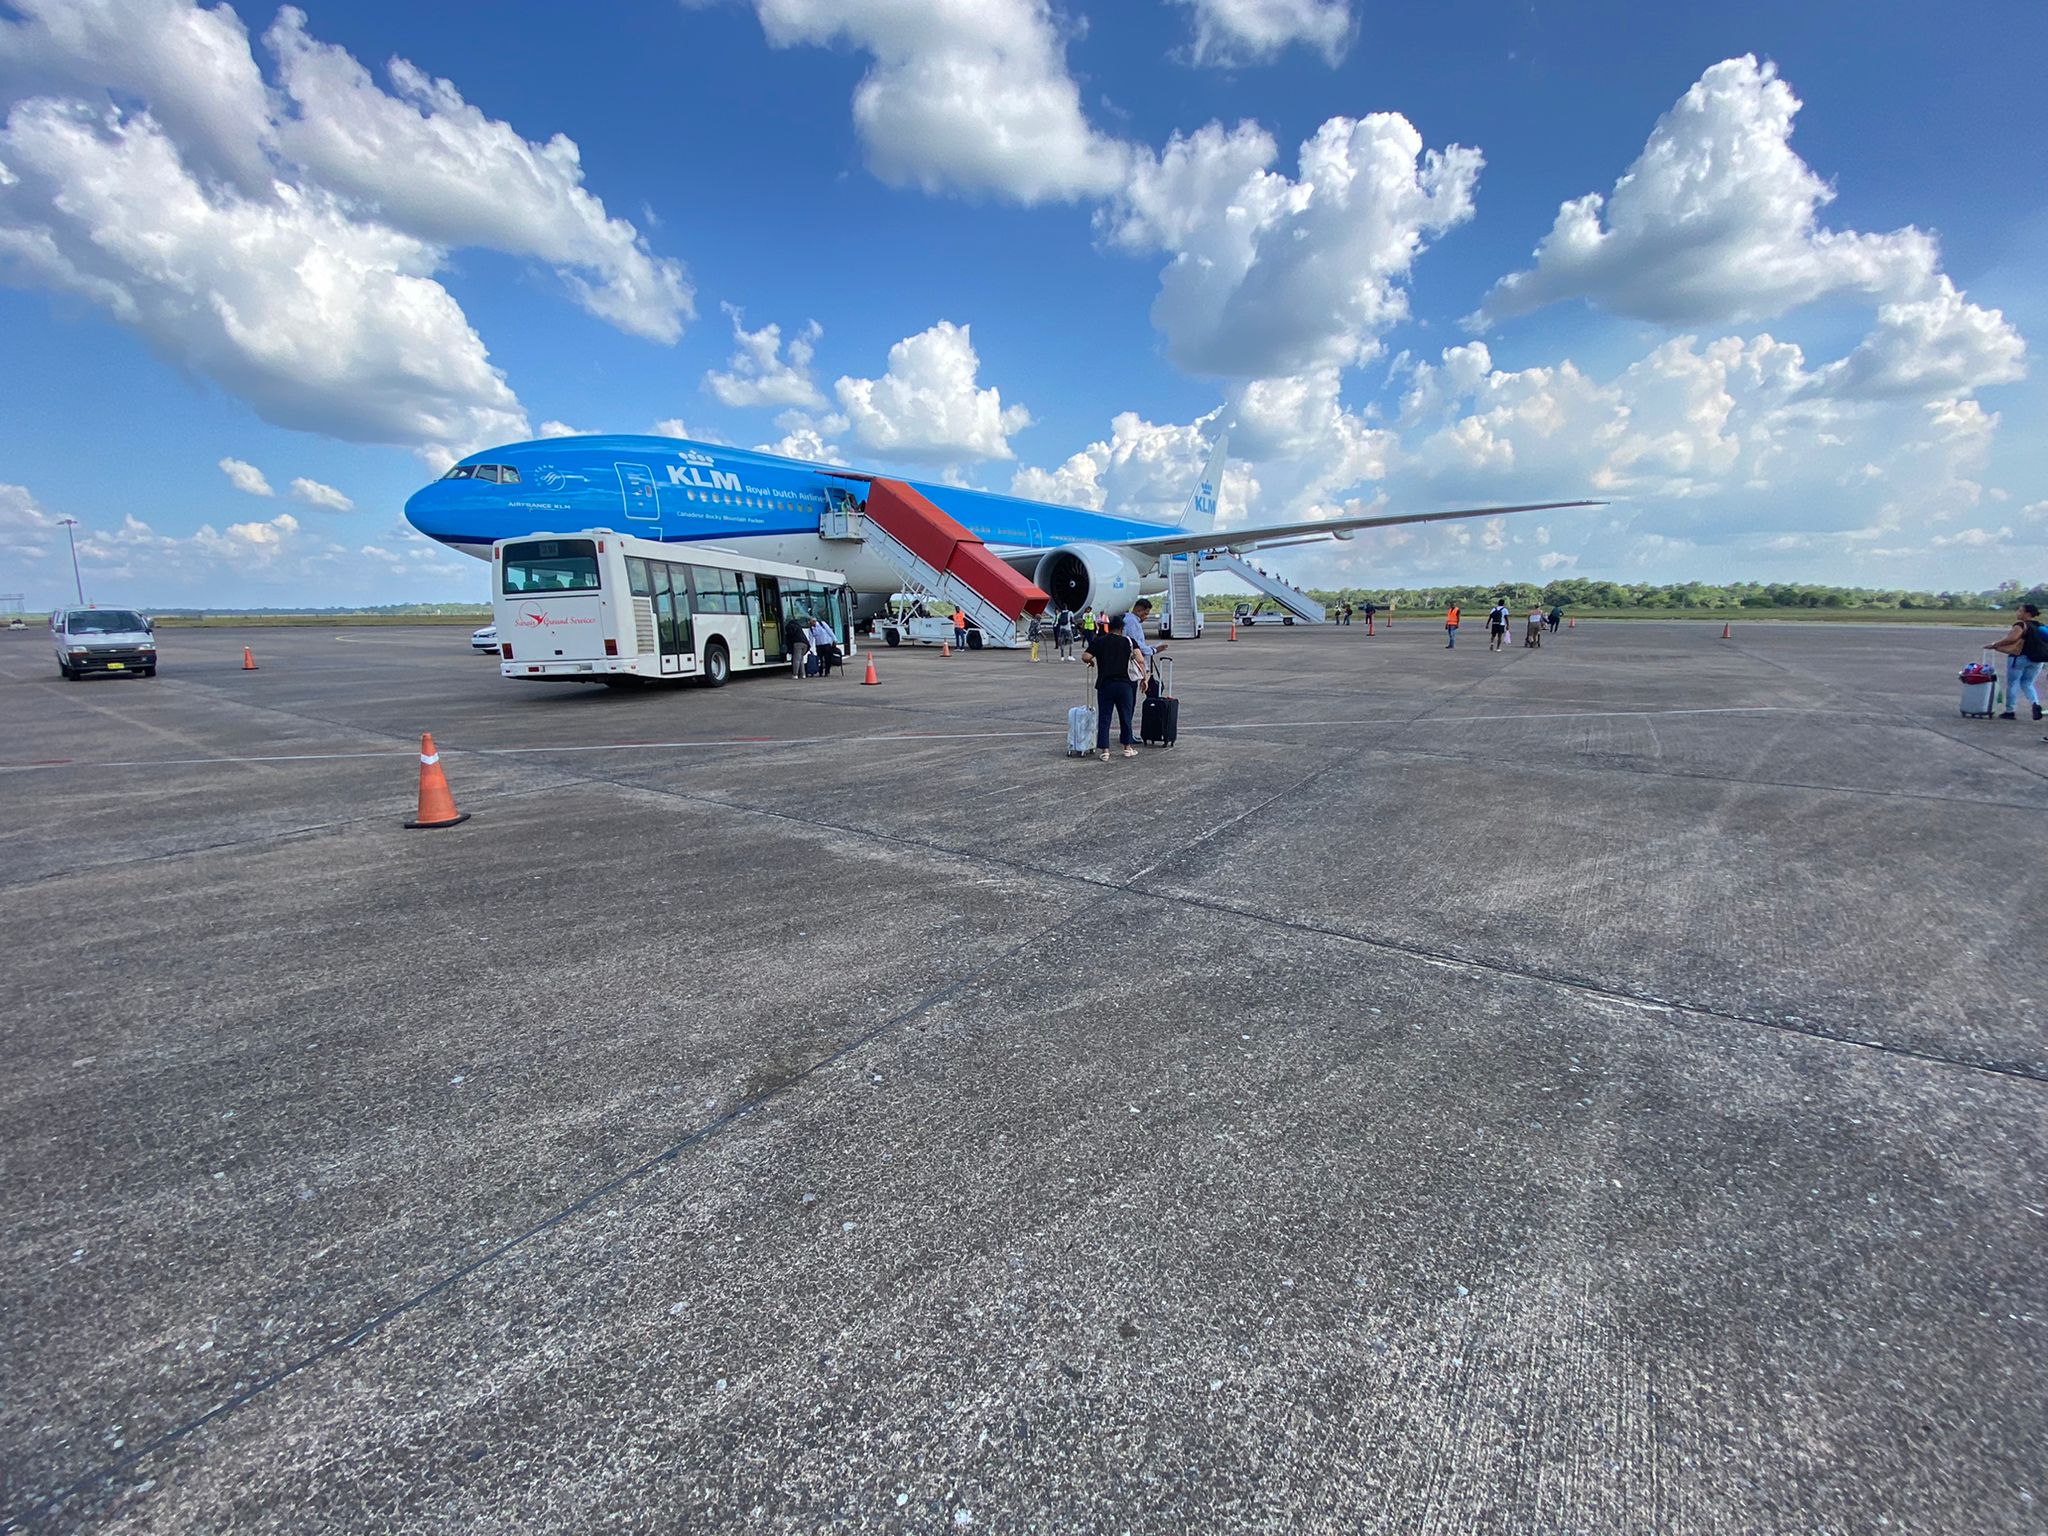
1475, 55, 1937, 326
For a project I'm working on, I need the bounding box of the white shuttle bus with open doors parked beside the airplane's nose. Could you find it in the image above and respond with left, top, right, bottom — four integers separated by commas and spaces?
492, 528, 854, 688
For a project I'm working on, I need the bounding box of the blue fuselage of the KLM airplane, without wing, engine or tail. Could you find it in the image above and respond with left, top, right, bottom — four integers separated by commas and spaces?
406, 436, 1171, 598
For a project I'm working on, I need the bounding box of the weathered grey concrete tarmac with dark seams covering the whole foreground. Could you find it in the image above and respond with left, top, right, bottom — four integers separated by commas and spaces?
0, 618, 2048, 1536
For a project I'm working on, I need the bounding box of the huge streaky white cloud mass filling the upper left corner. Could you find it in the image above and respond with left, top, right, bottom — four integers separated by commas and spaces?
0, 0, 690, 463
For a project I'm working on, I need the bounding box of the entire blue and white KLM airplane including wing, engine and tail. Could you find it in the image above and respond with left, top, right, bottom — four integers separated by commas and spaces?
406, 436, 1597, 610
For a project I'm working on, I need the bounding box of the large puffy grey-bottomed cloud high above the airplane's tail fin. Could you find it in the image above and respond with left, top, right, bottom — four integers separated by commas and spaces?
1100, 113, 1483, 379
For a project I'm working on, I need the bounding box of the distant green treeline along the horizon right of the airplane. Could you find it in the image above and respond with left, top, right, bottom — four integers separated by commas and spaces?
1202, 575, 2048, 612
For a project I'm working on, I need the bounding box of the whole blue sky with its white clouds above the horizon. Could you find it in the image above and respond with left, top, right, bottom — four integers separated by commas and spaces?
0, 0, 2048, 606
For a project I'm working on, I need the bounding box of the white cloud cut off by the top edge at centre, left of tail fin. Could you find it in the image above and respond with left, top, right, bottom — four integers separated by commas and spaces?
754, 0, 1128, 203
